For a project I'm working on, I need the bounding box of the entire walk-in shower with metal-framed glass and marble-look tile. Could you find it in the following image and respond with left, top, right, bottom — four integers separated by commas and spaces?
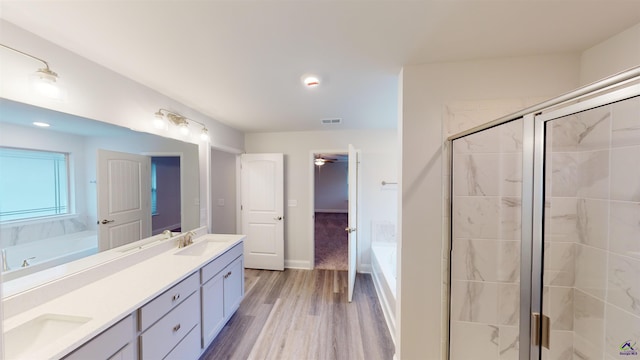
448, 68, 640, 360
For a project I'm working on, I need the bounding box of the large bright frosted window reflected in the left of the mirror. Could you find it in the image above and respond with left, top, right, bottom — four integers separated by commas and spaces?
0, 147, 69, 222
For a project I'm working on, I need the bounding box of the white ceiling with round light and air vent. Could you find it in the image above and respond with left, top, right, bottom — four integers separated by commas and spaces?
0, 0, 640, 132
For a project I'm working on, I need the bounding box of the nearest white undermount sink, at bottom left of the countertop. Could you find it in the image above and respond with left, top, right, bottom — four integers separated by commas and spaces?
4, 314, 91, 359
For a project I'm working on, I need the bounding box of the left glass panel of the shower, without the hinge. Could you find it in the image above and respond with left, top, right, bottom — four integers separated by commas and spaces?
449, 119, 523, 360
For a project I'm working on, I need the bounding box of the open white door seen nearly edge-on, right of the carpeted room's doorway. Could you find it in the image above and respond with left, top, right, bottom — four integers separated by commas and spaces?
346, 144, 359, 302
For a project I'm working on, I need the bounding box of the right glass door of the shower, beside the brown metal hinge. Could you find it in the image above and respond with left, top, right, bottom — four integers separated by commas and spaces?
536, 86, 640, 360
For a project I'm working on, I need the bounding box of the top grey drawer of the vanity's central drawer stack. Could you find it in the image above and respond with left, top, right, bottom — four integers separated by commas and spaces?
138, 272, 200, 331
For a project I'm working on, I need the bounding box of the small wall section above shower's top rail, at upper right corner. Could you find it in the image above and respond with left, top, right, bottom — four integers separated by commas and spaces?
580, 23, 640, 85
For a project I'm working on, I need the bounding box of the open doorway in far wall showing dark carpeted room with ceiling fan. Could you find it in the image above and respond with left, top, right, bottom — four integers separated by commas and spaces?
313, 152, 349, 271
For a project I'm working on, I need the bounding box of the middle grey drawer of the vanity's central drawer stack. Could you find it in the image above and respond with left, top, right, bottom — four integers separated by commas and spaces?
140, 294, 200, 360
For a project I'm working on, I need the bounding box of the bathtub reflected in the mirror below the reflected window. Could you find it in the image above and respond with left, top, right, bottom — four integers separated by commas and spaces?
2, 231, 98, 281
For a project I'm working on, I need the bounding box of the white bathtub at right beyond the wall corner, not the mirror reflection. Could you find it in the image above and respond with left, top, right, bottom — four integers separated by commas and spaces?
371, 242, 397, 343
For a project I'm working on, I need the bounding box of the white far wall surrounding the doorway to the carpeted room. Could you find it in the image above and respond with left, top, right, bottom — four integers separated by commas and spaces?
245, 130, 397, 272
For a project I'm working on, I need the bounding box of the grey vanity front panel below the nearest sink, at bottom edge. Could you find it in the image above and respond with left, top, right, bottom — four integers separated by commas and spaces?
64, 315, 134, 360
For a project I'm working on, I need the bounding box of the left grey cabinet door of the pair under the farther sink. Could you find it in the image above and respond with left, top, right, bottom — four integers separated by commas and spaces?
202, 271, 226, 347
